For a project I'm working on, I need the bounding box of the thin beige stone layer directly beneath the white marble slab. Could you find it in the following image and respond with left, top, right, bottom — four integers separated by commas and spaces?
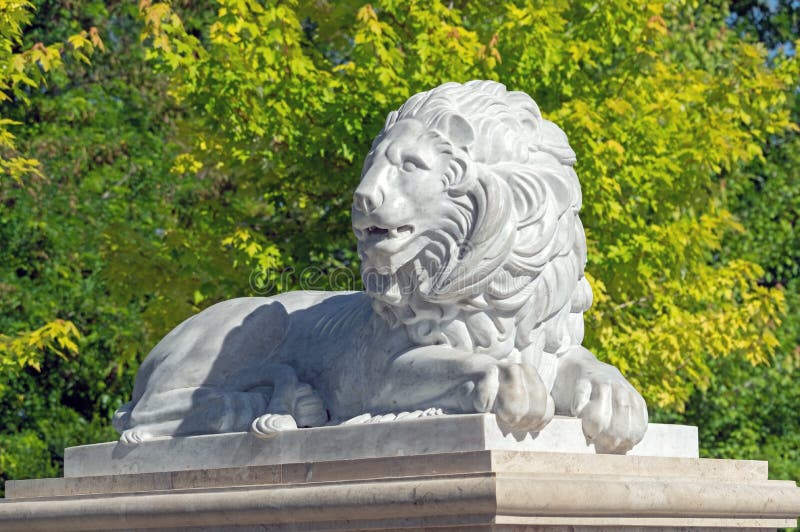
6, 451, 767, 499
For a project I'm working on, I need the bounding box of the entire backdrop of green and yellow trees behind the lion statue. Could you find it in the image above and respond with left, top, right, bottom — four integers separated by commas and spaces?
0, 0, 800, 488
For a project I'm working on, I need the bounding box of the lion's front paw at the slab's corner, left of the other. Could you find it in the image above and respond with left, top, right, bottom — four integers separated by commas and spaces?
473, 364, 555, 432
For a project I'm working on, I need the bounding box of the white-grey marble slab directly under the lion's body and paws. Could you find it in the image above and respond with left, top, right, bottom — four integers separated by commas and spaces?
69, 414, 698, 477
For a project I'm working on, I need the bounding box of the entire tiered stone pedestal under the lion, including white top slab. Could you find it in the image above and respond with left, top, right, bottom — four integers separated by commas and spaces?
0, 415, 800, 531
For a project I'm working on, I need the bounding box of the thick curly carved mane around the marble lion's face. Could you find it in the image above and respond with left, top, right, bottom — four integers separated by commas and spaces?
359, 81, 592, 387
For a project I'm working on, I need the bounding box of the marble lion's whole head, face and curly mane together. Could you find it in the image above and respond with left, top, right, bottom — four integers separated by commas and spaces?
353, 81, 592, 386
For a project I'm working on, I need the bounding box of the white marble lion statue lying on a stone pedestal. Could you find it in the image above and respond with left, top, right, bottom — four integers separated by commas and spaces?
114, 81, 647, 453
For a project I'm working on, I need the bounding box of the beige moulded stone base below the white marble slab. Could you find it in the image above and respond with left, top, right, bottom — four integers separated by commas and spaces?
0, 450, 800, 532
